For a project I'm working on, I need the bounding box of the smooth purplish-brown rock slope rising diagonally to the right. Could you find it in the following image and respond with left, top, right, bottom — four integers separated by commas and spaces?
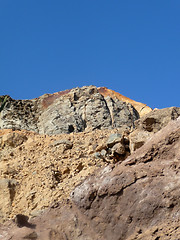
0, 118, 180, 240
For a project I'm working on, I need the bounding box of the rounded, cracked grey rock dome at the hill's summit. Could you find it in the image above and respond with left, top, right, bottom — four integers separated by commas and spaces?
39, 86, 139, 135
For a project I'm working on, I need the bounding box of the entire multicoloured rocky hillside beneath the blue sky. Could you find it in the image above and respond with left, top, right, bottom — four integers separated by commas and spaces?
0, 86, 180, 240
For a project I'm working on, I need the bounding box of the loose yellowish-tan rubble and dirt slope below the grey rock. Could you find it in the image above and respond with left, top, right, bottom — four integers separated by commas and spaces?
0, 126, 125, 222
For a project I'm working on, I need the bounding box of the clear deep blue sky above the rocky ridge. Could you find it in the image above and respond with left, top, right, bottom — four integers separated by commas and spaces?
0, 0, 180, 108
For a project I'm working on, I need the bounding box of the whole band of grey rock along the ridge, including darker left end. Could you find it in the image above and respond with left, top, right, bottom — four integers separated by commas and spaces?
0, 86, 139, 135
